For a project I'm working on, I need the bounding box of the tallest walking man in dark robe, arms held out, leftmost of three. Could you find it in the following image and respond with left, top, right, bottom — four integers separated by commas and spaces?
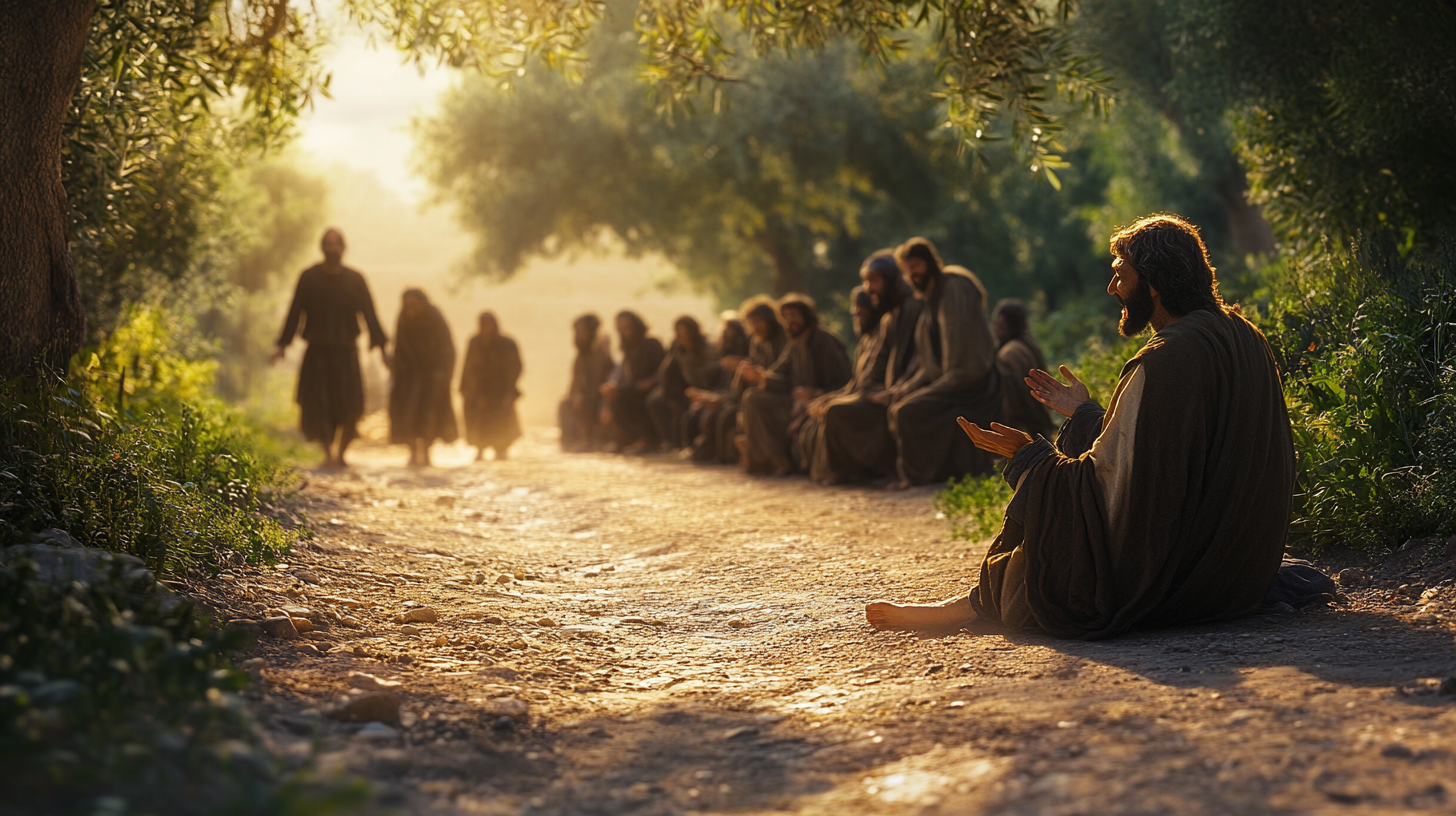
269, 229, 395, 468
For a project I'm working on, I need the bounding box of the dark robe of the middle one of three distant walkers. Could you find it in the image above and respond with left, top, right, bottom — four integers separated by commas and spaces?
389, 305, 459, 444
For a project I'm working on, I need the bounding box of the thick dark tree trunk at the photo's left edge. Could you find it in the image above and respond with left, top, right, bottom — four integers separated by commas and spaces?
0, 0, 96, 377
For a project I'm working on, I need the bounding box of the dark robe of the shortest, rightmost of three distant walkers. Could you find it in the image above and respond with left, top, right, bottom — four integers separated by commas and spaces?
460, 335, 521, 453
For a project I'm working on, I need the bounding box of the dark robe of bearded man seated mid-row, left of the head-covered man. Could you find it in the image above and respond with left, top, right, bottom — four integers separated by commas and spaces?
740, 325, 850, 474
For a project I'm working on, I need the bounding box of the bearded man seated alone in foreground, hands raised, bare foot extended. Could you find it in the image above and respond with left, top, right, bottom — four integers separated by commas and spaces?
866, 216, 1310, 640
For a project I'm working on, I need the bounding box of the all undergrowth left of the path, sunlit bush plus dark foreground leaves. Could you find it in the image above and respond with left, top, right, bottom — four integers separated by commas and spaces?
0, 310, 364, 815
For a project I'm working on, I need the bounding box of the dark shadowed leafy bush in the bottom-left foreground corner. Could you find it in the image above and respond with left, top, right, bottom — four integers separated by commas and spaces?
0, 546, 363, 815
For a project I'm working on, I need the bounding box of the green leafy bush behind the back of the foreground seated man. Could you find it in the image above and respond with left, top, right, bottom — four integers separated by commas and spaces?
1262, 240, 1456, 551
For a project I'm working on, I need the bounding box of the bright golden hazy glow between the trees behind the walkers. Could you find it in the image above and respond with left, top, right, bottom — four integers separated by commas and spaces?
288, 20, 713, 424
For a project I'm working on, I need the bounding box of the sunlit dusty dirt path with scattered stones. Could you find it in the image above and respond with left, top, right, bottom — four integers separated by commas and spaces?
202, 442, 1456, 815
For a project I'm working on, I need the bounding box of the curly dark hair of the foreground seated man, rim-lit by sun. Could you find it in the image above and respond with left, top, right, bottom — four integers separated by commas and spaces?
1108, 213, 1223, 318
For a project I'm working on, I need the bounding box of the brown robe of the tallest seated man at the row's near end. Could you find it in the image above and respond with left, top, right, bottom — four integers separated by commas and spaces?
888, 265, 1002, 484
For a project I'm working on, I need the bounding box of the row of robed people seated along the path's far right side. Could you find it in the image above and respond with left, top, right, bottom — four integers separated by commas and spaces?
561, 238, 1054, 488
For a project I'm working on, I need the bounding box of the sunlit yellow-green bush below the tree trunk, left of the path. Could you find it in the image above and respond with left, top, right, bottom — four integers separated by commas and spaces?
0, 310, 294, 573
